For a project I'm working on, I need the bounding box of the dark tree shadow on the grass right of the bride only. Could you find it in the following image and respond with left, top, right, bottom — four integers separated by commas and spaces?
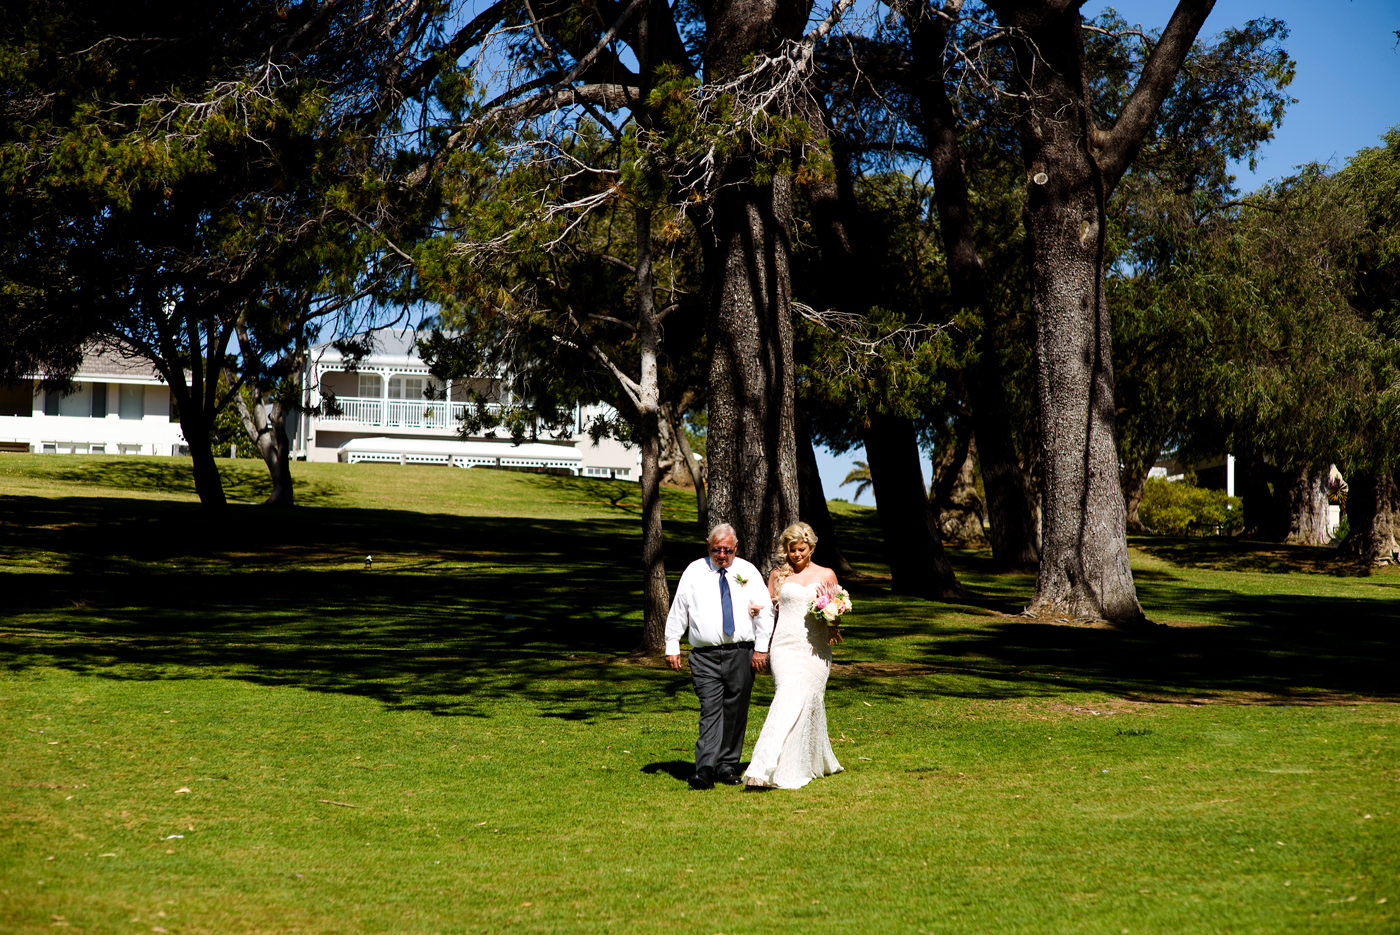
839, 579, 1400, 704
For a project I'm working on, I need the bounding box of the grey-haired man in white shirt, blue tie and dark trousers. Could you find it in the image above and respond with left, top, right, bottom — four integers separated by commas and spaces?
666, 523, 773, 789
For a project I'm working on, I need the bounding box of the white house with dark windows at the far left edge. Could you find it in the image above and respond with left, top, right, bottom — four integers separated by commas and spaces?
0, 350, 185, 455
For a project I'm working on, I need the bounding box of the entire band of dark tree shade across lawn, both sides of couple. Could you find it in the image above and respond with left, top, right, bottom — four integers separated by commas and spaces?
0, 497, 1400, 721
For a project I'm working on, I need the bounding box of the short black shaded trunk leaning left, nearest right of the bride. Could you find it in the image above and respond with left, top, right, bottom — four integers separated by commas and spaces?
865, 416, 962, 598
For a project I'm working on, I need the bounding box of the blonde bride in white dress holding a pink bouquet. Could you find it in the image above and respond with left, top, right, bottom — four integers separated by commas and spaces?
743, 522, 841, 789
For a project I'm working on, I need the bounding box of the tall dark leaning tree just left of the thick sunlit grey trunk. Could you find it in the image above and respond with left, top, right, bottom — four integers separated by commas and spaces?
882, 0, 1039, 568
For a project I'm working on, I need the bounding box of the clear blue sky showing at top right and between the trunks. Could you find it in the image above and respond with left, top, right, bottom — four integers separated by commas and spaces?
818, 0, 1400, 504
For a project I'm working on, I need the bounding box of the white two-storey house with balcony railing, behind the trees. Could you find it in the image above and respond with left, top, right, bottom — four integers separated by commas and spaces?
303, 329, 640, 480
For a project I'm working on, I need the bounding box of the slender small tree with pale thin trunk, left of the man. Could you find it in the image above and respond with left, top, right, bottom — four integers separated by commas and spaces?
417, 123, 706, 655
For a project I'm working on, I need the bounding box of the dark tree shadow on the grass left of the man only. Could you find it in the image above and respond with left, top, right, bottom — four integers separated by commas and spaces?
0, 498, 700, 719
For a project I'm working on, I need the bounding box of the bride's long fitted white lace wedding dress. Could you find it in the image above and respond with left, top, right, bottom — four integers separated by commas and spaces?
743, 582, 841, 789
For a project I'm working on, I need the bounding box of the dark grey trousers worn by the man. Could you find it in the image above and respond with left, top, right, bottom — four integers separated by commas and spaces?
690, 642, 753, 773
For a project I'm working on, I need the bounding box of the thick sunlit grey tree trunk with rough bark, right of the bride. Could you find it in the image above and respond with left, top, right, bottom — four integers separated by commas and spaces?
997, 3, 1145, 624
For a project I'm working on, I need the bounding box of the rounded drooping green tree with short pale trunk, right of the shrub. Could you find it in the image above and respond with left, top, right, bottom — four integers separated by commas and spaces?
1177, 167, 1380, 544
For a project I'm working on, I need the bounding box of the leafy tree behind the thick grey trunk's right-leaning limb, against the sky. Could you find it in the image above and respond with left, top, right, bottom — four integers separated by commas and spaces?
1086, 14, 1294, 529
